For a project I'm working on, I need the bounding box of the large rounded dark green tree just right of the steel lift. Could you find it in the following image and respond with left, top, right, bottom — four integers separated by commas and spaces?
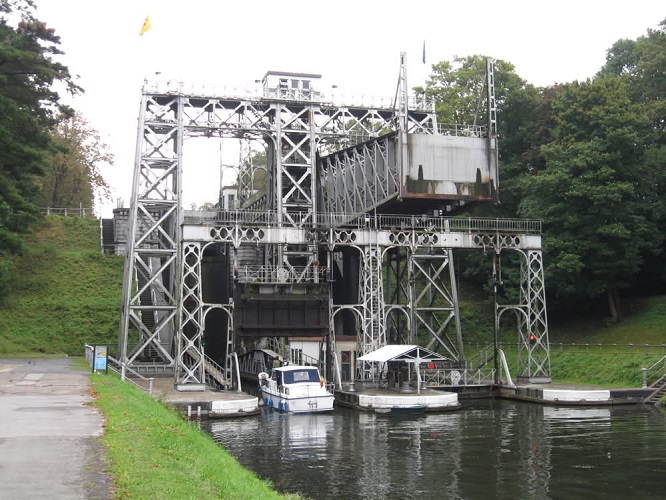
520, 77, 662, 319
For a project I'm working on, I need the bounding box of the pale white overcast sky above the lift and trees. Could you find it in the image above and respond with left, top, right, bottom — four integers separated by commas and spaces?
36, 0, 666, 216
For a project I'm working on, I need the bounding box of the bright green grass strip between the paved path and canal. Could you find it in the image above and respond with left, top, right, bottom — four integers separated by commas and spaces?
91, 374, 301, 500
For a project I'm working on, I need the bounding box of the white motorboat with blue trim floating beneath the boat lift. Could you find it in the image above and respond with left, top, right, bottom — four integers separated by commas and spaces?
259, 365, 335, 413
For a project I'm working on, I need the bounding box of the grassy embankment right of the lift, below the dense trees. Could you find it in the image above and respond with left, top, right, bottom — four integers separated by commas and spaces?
461, 290, 666, 387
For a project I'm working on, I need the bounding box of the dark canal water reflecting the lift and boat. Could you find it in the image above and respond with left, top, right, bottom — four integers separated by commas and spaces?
201, 400, 666, 500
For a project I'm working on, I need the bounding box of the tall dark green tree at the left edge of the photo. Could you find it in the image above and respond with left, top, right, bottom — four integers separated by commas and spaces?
0, 0, 81, 291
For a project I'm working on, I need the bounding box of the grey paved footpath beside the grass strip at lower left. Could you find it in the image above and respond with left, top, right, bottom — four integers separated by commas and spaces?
0, 358, 112, 500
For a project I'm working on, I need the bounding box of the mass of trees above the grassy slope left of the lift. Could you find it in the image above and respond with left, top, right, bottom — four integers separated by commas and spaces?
0, 0, 112, 297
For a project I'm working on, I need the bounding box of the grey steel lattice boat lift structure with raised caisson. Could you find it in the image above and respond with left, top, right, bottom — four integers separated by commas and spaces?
119, 56, 550, 390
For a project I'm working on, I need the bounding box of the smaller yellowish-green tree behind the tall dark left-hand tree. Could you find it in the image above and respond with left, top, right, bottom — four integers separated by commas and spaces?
39, 113, 113, 208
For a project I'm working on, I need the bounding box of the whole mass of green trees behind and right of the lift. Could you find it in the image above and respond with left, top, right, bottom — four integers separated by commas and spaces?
425, 21, 666, 321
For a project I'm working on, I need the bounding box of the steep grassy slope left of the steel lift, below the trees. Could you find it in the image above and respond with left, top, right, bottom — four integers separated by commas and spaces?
0, 216, 123, 355
